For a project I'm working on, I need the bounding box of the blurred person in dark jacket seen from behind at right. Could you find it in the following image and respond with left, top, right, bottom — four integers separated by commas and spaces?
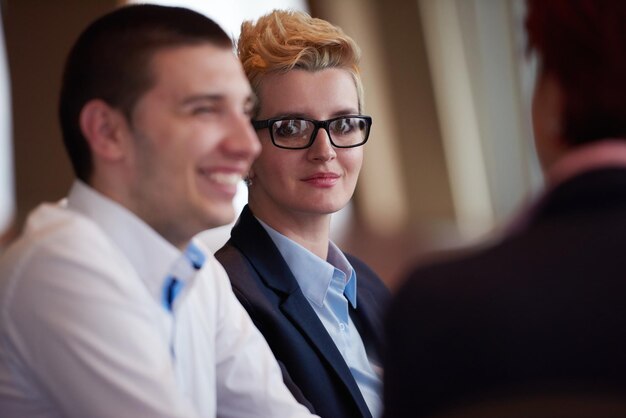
384, 0, 626, 418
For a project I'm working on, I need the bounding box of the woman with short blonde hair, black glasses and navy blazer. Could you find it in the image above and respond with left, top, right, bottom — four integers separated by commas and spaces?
216, 11, 389, 418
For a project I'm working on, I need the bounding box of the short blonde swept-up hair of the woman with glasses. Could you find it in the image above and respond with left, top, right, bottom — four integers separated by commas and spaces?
237, 10, 363, 112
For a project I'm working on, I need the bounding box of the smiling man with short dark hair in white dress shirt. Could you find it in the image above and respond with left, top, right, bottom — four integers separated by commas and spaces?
0, 5, 310, 417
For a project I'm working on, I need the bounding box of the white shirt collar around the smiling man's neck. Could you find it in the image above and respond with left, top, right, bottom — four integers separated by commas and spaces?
67, 180, 199, 301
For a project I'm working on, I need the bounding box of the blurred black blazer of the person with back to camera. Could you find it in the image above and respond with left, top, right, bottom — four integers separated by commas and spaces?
383, 168, 626, 418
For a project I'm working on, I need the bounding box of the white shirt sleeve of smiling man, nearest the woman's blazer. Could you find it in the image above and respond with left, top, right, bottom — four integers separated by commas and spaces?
207, 258, 315, 418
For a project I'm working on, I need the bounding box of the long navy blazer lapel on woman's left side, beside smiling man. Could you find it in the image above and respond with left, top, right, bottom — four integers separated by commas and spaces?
231, 206, 371, 417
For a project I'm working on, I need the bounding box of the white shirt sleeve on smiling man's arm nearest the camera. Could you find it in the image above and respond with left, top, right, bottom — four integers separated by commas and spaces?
2, 225, 198, 418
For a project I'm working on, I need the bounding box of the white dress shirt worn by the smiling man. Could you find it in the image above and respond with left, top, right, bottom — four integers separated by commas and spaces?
0, 182, 310, 418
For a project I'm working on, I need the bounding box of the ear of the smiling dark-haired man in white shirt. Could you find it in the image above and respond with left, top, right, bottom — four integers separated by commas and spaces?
80, 99, 128, 161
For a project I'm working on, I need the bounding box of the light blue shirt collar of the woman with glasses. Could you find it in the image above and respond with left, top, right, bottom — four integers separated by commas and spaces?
257, 218, 357, 308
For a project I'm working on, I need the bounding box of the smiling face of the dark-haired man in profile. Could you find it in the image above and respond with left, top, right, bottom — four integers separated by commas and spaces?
123, 44, 260, 247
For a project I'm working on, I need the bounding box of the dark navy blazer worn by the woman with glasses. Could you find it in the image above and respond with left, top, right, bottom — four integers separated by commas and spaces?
215, 206, 389, 418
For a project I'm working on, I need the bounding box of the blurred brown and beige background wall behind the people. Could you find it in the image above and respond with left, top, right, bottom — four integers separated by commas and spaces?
0, 0, 541, 288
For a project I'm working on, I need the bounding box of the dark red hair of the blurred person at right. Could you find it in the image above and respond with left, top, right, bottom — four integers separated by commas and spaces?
526, 0, 626, 145
